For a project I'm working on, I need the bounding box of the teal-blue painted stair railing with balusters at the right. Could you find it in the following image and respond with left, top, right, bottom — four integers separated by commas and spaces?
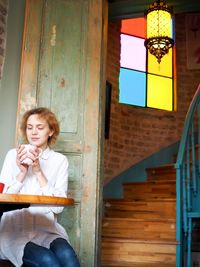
175, 85, 200, 267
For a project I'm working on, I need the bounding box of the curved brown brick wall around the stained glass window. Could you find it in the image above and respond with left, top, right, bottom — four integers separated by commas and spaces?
104, 14, 200, 183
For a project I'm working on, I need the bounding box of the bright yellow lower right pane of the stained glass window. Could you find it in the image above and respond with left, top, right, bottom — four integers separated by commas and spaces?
147, 74, 173, 111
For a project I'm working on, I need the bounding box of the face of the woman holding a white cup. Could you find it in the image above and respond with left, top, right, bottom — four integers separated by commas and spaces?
26, 114, 53, 150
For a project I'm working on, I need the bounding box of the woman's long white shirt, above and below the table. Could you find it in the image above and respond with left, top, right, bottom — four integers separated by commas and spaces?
0, 148, 68, 267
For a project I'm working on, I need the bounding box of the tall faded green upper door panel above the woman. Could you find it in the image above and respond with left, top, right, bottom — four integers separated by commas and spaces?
38, 0, 83, 138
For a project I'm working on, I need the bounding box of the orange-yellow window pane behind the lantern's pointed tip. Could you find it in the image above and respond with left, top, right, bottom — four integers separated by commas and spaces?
147, 48, 173, 78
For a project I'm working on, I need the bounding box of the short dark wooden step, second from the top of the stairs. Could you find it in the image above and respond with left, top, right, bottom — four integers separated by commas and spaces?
123, 182, 176, 200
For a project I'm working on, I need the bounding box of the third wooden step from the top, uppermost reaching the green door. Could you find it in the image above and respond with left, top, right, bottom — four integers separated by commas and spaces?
104, 198, 176, 218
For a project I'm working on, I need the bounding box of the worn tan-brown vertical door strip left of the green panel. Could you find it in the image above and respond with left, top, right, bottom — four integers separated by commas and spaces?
16, 0, 43, 134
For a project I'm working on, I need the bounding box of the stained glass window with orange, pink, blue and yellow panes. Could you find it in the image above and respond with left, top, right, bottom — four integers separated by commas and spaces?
119, 18, 175, 111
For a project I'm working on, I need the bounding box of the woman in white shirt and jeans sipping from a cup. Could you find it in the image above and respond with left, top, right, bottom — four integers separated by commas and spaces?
0, 107, 80, 267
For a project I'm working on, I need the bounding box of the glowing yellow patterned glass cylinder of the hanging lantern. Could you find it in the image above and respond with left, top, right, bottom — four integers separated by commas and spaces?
147, 10, 172, 38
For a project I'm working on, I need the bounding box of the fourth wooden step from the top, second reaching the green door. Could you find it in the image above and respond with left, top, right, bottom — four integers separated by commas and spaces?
102, 218, 175, 241
